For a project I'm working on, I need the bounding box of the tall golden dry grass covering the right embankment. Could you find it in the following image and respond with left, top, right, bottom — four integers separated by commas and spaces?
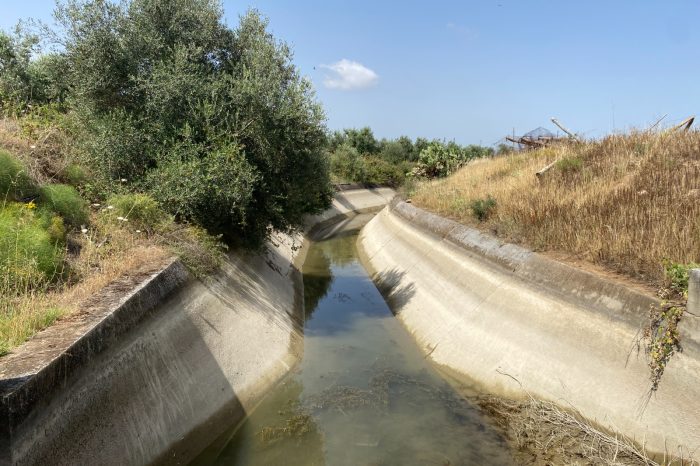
413, 132, 700, 285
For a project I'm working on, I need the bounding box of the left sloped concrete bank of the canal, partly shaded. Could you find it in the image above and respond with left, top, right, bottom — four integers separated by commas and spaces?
0, 189, 393, 465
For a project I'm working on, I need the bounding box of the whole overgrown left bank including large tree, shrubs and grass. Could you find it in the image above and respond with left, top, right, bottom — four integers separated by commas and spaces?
0, 0, 332, 355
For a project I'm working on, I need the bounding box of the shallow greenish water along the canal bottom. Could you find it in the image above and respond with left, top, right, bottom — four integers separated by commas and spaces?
194, 236, 512, 465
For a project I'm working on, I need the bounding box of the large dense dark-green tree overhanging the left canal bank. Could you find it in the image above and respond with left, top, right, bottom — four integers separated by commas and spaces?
58, 0, 332, 246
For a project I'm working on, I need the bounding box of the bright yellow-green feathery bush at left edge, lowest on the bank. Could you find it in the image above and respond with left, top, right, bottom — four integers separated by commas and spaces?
0, 203, 64, 293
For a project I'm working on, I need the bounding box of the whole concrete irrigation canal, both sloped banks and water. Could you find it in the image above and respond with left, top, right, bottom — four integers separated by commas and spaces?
0, 189, 700, 465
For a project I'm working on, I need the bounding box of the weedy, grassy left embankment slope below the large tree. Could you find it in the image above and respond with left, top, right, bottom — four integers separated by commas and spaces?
0, 116, 222, 356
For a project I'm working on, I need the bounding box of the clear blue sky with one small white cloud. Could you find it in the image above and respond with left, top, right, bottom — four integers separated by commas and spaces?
0, 0, 700, 145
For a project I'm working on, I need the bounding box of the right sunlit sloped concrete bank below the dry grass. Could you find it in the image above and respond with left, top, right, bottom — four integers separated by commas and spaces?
358, 200, 700, 458
